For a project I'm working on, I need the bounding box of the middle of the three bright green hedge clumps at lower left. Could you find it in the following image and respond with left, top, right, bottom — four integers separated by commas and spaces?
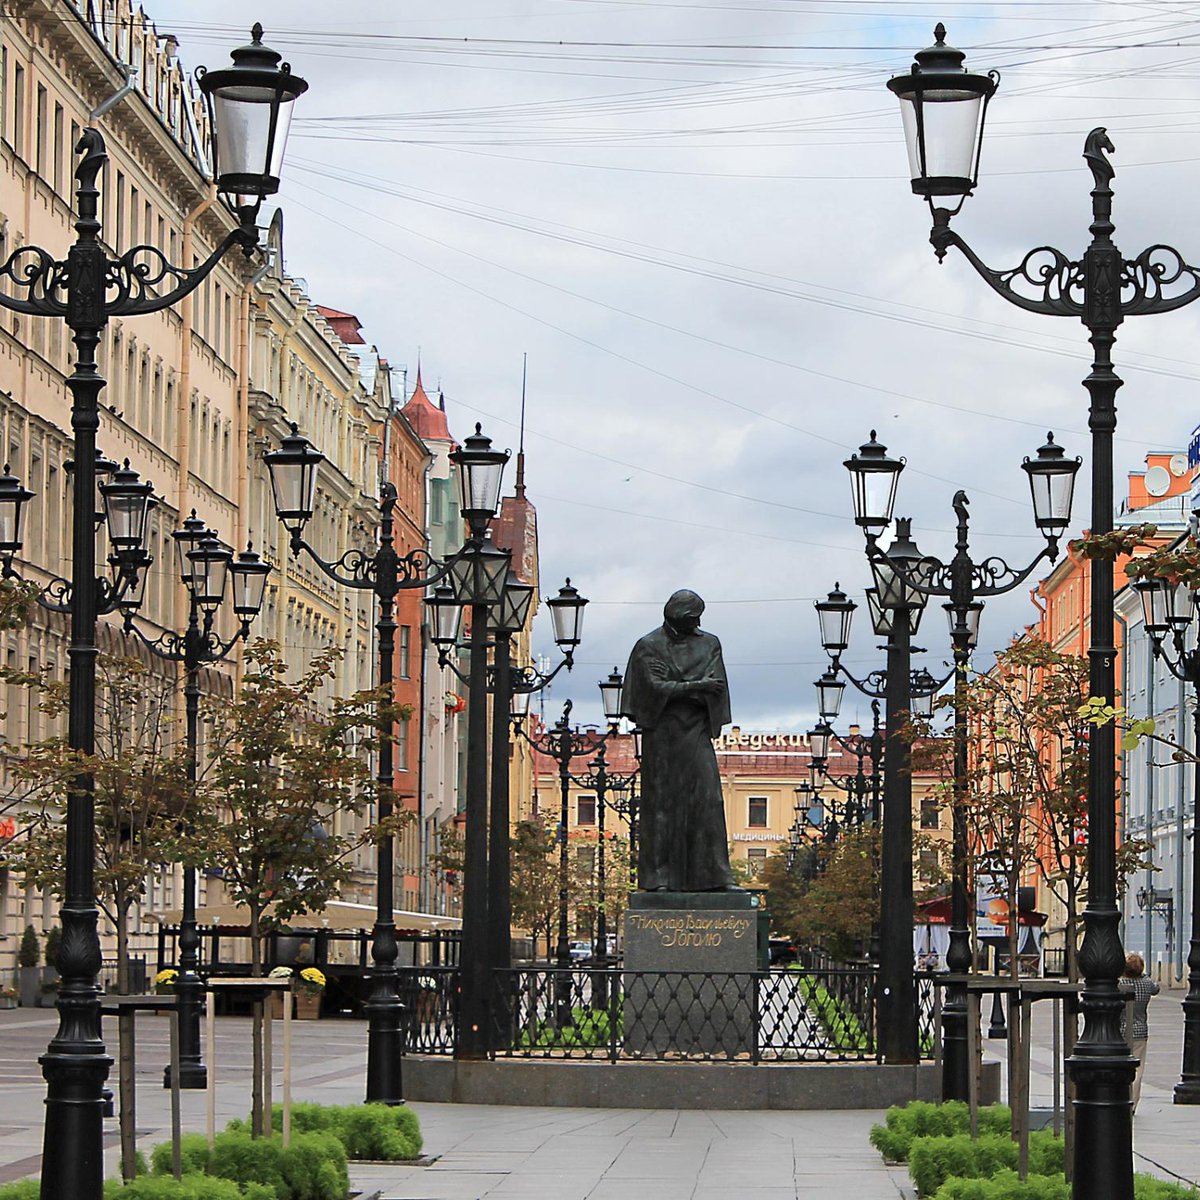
151, 1129, 350, 1200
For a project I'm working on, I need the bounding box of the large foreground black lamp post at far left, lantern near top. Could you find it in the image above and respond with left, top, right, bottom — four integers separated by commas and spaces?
0, 25, 307, 1200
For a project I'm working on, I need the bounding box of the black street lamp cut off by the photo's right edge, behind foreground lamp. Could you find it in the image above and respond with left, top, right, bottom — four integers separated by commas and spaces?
1137, 576, 1200, 1104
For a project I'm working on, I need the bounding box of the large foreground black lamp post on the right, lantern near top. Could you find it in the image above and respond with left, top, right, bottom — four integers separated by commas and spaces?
889, 25, 1200, 1200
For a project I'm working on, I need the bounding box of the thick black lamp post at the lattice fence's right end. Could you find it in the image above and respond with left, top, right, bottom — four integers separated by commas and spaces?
809, 566, 944, 1064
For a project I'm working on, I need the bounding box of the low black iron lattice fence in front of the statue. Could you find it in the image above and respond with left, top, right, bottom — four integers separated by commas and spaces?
401, 966, 937, 1063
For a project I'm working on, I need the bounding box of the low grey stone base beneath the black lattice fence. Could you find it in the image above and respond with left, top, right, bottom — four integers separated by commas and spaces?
403, 1056, 1000, 1110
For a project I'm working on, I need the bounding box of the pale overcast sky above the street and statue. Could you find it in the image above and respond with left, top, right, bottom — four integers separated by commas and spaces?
146, 0, 1200, 731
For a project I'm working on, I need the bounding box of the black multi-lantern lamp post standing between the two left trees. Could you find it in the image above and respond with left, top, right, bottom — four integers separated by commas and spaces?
121, 509, 271, 1088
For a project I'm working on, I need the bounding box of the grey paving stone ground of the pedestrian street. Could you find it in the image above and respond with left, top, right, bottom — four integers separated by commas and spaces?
0, 992, 1200, 1200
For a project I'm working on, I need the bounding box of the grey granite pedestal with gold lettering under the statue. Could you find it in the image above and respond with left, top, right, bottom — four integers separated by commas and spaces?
624, 892, 758, 1058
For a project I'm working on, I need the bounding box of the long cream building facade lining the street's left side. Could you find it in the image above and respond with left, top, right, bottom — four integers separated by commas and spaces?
0, 0, 403, 970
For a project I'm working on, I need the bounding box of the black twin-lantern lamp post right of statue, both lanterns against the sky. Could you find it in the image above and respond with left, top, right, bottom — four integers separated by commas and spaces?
846, 430, 1080, 1100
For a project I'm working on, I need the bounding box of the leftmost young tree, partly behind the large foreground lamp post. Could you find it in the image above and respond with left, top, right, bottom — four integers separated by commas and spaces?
6, 654, 192, 992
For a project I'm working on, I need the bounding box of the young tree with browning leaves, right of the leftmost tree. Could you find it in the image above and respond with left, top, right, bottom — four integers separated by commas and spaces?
187, 641, 409, 974
